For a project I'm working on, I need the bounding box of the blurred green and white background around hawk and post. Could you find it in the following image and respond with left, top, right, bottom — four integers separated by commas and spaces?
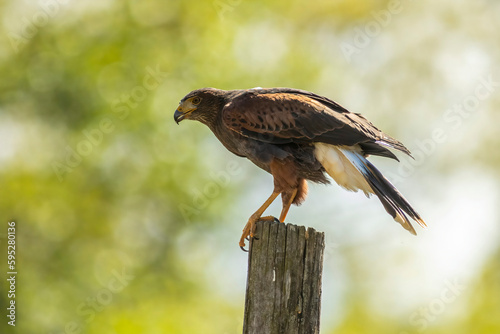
0, 0, 500, 334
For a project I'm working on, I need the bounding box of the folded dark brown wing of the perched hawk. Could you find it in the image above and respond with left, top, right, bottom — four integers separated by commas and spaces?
222, 88, 410, 160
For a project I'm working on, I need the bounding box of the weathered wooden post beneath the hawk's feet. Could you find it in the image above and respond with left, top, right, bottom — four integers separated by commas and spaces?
243, 222, 325, 334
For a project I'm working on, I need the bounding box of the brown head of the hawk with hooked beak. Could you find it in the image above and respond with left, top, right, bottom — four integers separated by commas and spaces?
174, 88, 226, 125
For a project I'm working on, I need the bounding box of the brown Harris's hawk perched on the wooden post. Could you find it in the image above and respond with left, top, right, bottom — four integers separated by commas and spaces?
174, 88, 426, 248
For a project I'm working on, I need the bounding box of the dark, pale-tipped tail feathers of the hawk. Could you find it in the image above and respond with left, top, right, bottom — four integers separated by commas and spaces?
363, 159, 427, 235
